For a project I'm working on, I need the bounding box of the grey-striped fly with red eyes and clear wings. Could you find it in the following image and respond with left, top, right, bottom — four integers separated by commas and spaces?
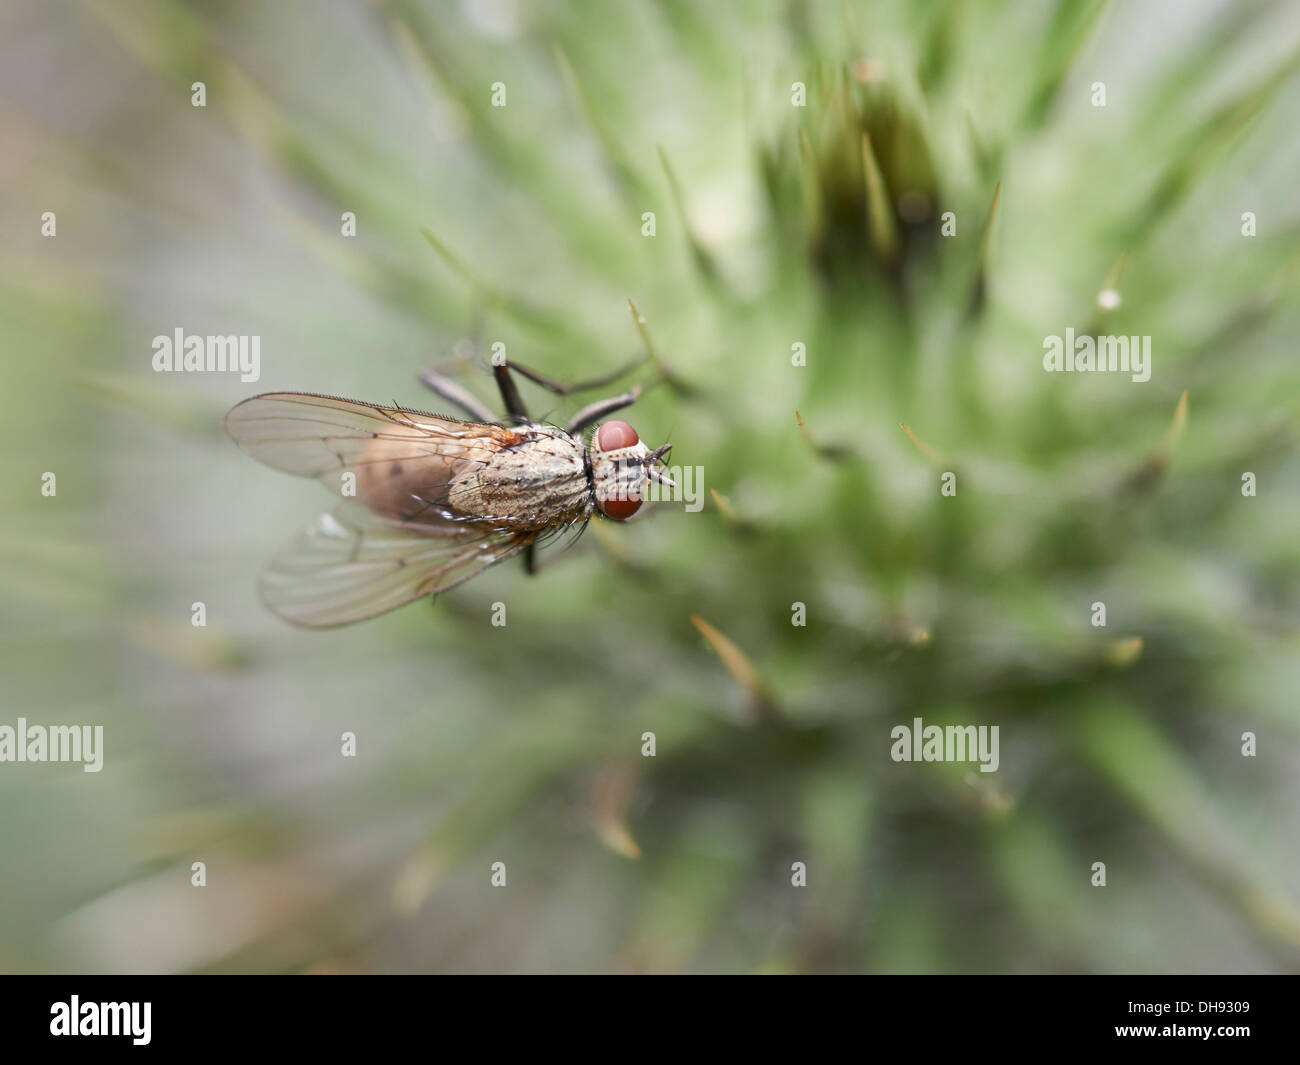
225, 362, 673, 628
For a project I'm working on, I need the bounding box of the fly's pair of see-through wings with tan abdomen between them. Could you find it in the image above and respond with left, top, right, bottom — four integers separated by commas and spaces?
226, 393, 536, 628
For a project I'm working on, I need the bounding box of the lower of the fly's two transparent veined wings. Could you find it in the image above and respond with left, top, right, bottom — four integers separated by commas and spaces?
260, 501, 536, 628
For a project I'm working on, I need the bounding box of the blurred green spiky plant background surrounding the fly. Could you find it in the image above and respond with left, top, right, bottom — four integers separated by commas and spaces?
0, 0, 1300, 973
